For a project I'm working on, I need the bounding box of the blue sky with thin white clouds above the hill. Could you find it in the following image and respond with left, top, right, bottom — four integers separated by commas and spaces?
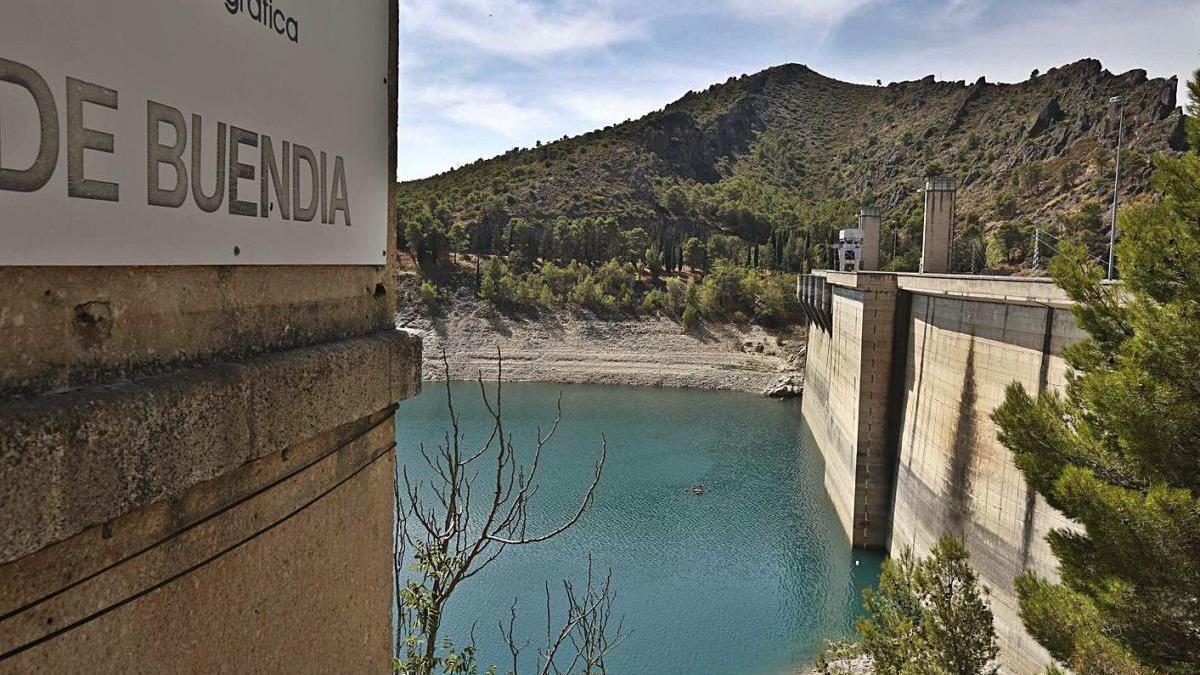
397, 0, 1200, 179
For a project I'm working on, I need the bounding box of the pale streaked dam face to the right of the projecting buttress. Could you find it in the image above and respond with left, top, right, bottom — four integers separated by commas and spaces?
892, 295, 1080, 673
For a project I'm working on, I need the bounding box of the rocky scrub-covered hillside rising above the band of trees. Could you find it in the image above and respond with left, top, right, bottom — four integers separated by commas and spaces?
398, 60, 1184, 269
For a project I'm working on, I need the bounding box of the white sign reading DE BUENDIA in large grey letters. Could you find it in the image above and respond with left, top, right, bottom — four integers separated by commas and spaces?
0, 0, 392, 265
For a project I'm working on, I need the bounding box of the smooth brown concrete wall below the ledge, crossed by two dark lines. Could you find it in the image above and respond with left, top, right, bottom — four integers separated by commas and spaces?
0, 406, 396, 674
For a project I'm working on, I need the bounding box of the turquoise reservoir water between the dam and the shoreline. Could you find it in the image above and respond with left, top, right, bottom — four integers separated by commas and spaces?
396, 383, 880, 675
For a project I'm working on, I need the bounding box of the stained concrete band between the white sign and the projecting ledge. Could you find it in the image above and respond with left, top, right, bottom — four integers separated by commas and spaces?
0, 265, 395, 400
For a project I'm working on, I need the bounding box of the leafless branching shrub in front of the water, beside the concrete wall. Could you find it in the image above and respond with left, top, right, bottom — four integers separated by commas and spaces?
394, 350, 620, 675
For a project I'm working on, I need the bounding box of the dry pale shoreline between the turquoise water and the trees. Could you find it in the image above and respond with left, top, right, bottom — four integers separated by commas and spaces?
396, 298, 804, 394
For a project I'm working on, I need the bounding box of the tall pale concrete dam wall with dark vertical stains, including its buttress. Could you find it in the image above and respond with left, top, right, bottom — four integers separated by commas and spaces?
800, 271, 1082, 674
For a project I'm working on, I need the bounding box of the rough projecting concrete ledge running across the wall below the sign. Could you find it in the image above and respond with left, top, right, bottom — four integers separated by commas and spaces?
0, 330, 421, 563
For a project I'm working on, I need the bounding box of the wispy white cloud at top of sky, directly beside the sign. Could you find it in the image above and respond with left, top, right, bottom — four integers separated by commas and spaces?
401, 0, 643, 59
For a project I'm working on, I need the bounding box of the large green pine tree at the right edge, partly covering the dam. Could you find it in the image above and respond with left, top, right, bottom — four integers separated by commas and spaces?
995, 64, 1200, 674
